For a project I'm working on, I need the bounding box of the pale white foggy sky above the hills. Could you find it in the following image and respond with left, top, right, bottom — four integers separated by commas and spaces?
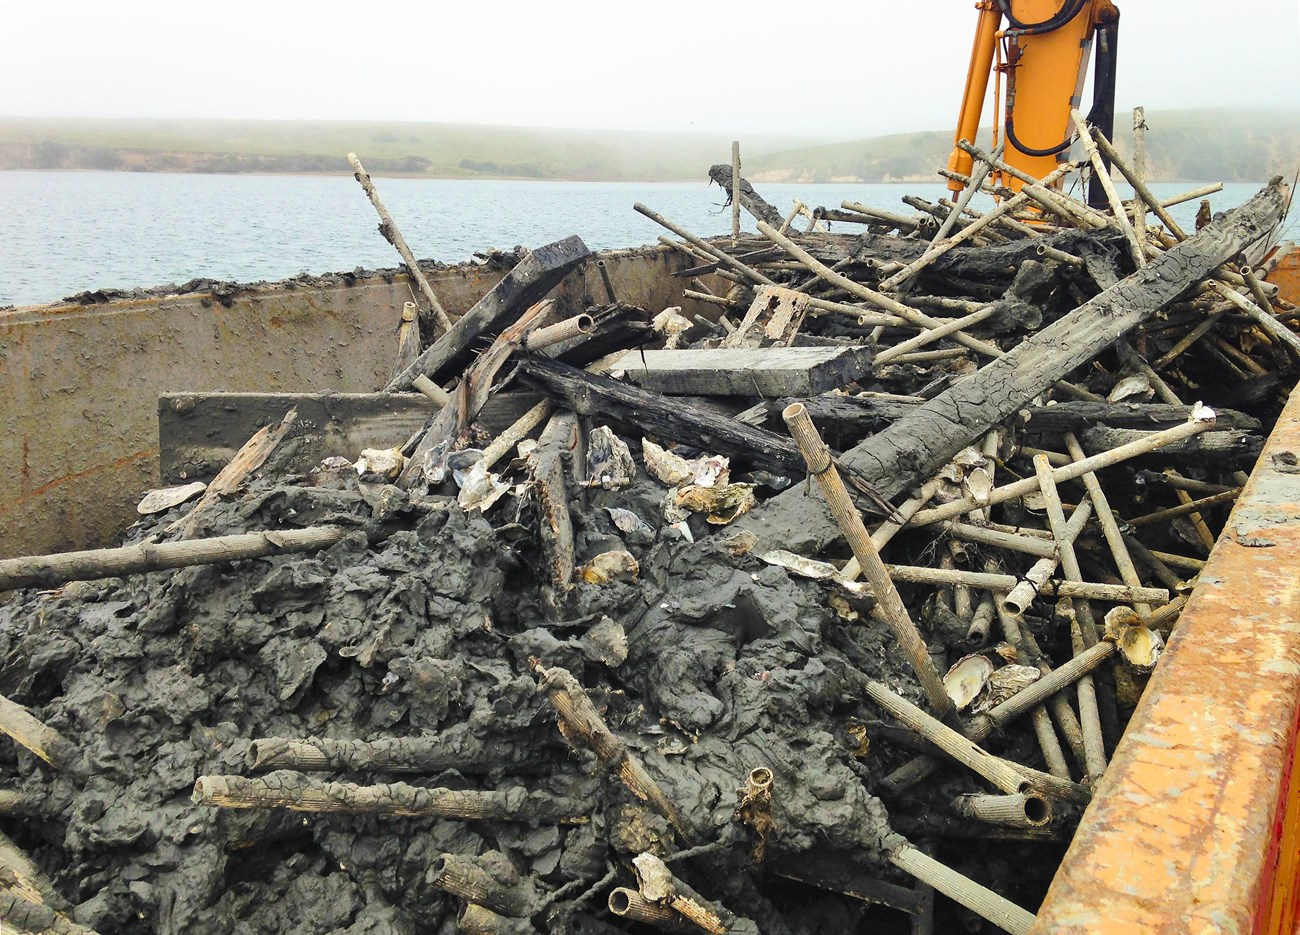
0, 0, 1300, 139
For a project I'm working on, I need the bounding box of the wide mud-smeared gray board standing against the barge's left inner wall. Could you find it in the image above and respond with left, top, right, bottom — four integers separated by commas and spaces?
159, 393, 538, 484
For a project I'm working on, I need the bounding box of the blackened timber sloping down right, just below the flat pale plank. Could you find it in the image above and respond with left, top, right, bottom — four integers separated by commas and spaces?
520, 358, 803, 477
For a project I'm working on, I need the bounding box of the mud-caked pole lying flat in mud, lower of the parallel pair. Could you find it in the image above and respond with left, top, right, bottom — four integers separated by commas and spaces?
191, 771, 590, 824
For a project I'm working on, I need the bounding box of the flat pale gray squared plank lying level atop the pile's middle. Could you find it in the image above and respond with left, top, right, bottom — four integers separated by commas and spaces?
611, 347, 871, 398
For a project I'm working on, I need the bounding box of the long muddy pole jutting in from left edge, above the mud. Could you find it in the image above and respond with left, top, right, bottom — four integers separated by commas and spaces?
0, 525, 347, 590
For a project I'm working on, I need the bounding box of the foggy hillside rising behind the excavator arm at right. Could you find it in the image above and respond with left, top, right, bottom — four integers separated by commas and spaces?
745, 109, 1300, 182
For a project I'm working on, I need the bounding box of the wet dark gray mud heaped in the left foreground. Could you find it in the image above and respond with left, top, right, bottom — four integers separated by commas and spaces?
0, 429, 935, 935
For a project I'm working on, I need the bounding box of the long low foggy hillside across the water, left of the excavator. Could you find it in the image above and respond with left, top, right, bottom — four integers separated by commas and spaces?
0, 117, 809, 181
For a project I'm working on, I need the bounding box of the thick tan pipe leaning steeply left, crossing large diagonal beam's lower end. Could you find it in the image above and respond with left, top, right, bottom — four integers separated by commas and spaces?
781, 403, 953, 718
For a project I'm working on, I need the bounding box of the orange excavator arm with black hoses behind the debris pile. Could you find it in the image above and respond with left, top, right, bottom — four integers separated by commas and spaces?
948, 0, 1119, 191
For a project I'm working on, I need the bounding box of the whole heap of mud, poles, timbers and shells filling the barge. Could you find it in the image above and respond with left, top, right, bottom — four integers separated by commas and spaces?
0, 139, 1300, 935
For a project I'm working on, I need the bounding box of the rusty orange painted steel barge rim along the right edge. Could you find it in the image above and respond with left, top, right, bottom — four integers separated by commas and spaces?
1034, 390, 1300, 935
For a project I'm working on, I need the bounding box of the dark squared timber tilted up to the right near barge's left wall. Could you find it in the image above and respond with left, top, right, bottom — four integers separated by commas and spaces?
384, 237, 592, 393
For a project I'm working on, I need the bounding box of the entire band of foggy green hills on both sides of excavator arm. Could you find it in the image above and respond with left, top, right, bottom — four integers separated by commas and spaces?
0, 109, 1300, 182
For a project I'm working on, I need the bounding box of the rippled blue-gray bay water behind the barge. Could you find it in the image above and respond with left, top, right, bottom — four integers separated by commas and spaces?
0, 172, 1300, 306
